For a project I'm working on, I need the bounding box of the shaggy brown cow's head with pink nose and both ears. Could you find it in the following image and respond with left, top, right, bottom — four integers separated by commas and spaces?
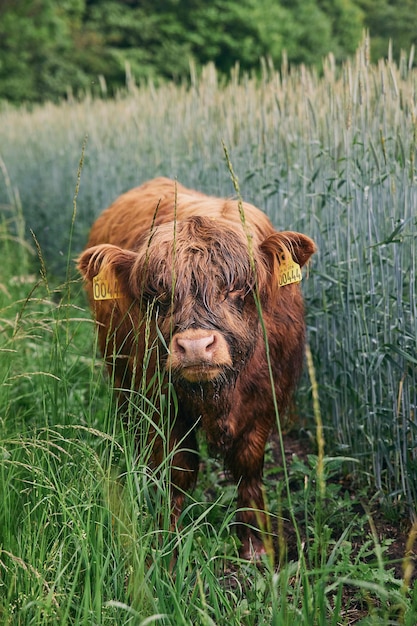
78, 217, 315, 383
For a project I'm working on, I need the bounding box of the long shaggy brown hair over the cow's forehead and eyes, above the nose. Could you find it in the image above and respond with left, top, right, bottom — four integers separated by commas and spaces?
130, 217, 262, 352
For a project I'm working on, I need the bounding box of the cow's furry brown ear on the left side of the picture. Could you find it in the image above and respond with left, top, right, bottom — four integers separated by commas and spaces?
77, 244, 137, 289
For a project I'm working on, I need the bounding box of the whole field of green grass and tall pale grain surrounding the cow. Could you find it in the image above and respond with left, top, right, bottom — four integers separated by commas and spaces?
0, 40, 417, 626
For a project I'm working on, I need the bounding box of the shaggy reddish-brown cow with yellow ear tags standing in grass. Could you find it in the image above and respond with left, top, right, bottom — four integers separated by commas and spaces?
78, 178, 315, 558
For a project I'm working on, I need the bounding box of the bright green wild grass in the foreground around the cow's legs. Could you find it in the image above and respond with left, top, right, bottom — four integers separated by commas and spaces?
0, 200, 417, 626
